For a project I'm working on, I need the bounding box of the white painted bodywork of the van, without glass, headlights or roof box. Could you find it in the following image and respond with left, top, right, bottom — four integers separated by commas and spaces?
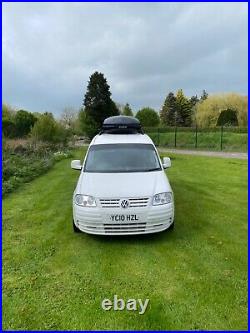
71, 134, 174, 235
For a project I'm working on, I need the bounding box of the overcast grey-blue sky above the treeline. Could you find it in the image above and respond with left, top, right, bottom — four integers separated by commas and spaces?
2, 3, 248, 115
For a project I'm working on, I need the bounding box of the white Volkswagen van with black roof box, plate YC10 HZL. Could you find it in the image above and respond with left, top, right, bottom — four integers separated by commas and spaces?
71, 116, 174, 235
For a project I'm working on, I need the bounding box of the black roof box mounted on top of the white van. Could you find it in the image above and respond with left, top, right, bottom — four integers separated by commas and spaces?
101, 116, 143, 134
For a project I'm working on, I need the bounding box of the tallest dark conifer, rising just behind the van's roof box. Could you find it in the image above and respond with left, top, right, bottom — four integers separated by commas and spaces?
83, 72, 119, 133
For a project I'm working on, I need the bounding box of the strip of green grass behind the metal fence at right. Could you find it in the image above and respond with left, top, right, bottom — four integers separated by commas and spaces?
148, 128, 248, 152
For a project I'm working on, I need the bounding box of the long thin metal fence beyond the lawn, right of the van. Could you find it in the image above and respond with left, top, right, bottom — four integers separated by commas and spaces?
144, 126, 248, 151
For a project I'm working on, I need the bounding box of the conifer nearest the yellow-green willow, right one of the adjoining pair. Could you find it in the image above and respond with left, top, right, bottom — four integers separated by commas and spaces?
176, 89, 192, 126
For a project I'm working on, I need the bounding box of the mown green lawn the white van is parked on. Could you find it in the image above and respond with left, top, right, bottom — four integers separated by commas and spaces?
2, 152, 247, 330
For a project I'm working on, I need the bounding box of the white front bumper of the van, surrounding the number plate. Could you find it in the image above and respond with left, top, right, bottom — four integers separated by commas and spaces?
73, 203, 174, 235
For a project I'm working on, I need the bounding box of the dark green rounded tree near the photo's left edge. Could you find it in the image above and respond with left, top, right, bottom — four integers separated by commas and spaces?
15, 110, 37, 137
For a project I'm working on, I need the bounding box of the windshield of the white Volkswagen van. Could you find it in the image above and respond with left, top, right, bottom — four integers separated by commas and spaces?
84, 144, 161, 172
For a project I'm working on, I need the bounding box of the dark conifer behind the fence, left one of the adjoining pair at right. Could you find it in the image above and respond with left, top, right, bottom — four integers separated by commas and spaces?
160, 92, 177, 126
